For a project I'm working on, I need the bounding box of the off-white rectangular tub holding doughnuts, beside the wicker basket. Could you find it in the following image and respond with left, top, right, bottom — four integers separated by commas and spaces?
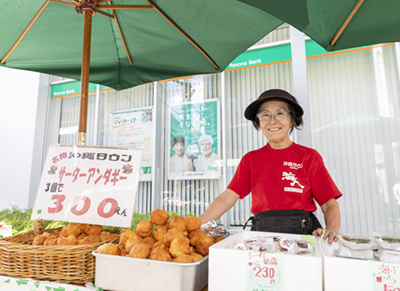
93, 252, 208, 291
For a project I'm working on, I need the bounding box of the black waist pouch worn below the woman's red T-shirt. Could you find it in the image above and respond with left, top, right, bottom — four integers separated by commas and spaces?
243, 209, 322, 234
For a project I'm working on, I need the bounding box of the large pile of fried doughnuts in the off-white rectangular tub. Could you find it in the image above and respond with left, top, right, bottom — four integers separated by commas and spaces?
96, 209, 222, 263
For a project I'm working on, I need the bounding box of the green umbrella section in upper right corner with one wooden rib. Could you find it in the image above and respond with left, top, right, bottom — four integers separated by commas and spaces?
241, 0, 400, 51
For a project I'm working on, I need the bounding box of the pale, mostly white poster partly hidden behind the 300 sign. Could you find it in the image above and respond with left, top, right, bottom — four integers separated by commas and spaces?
110, 107, 153, 181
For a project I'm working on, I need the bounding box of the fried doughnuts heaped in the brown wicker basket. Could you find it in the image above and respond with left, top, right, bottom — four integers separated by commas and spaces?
32, 223, 119, 246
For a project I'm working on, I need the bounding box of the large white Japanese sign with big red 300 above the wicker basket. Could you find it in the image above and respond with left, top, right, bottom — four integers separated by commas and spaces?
31, 146, 142, 227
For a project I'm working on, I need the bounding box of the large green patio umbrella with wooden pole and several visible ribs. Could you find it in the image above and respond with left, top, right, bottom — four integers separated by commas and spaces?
0, 0, 283, 144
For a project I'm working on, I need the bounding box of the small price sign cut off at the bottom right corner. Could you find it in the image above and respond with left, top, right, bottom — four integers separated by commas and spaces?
368, 261, 400, 291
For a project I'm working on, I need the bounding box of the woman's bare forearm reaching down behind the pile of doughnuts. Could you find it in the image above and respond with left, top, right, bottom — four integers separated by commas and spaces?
200, 189, 239, 224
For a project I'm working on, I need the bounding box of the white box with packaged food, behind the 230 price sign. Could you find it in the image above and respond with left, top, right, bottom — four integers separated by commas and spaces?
208, 231, 322, 291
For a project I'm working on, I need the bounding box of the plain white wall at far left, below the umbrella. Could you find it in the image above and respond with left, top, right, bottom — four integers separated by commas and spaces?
0, 67, 48, 210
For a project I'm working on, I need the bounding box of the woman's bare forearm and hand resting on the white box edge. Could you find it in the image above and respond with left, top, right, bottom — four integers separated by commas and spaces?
313, 198, 340, 244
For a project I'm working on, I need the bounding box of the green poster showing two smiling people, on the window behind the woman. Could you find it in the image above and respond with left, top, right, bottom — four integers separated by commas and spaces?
168, 99, 222, 180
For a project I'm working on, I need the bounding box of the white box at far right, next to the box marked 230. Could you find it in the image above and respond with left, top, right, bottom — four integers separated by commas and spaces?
320, 241, 375, 291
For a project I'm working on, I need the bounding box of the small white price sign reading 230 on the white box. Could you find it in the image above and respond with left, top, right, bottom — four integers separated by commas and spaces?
246, 251, 284, 291
